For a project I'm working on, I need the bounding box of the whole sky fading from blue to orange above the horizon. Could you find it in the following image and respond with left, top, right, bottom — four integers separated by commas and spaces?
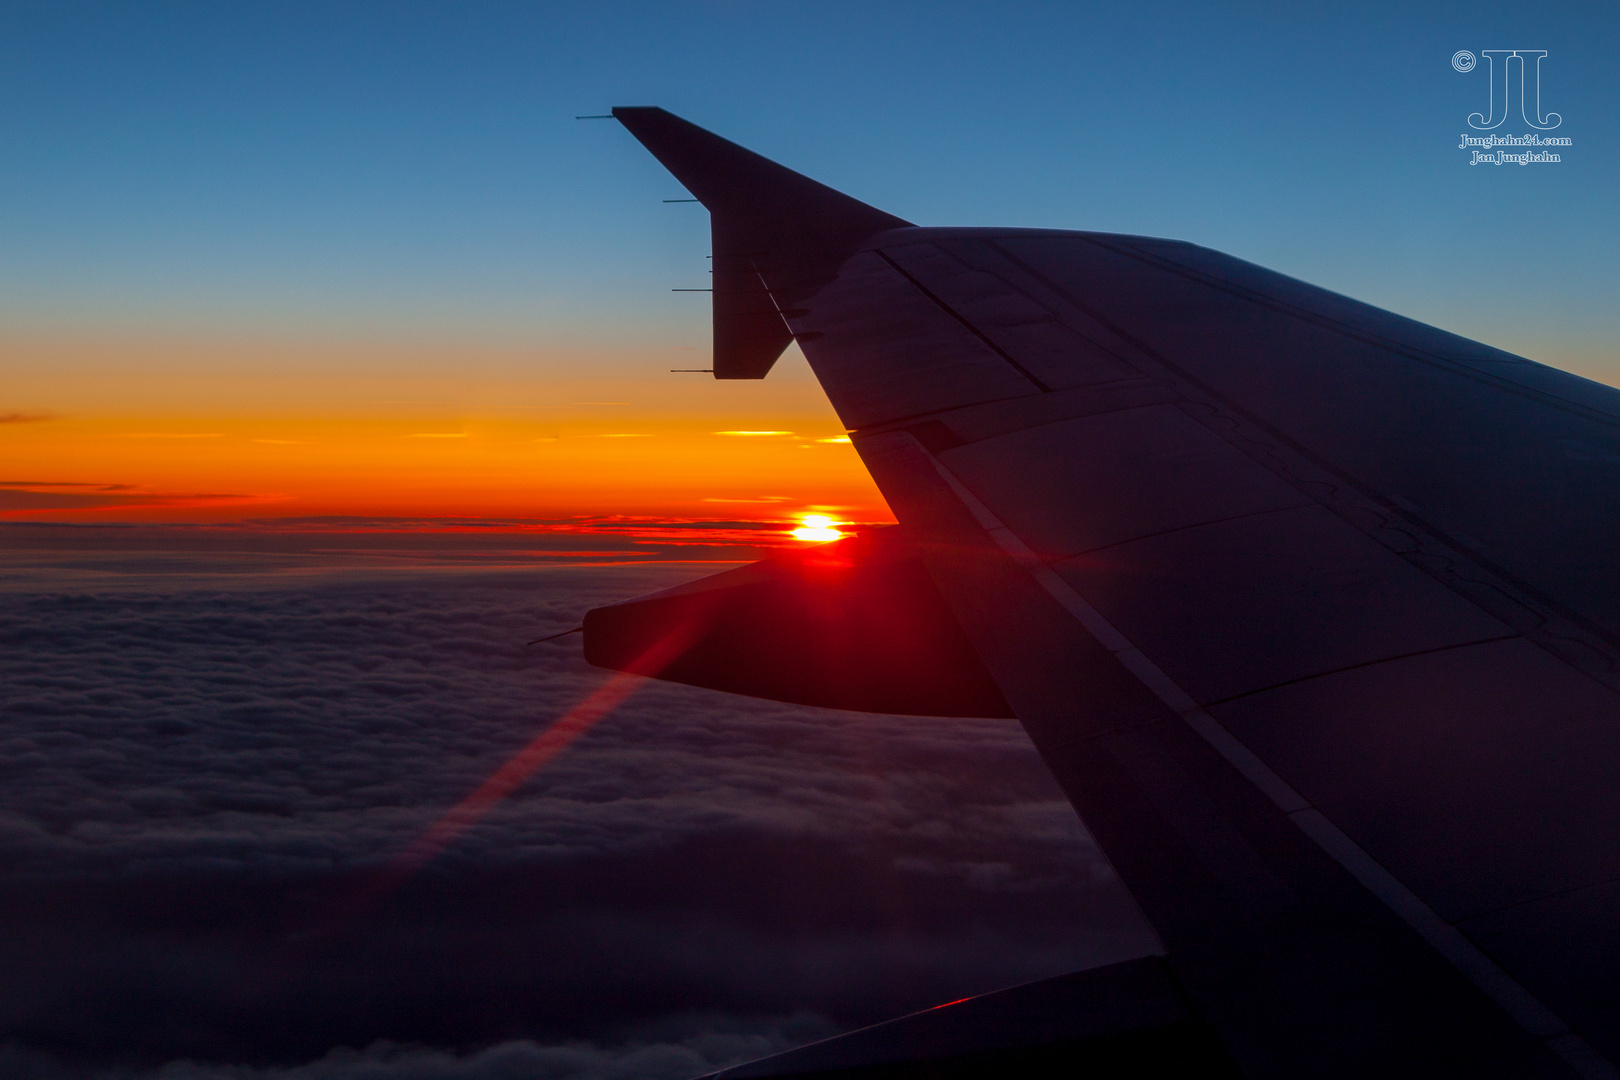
0, 2, 1620, 521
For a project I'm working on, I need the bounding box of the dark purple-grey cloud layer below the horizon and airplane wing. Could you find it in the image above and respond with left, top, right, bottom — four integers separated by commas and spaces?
0, 553, 1144, 1080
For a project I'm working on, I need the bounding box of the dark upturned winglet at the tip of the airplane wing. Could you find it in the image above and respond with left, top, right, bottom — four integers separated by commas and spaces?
612, 107, 910, 379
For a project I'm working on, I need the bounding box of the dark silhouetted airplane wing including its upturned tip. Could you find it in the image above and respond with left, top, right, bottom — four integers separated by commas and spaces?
586, 108, 1620, 1077
